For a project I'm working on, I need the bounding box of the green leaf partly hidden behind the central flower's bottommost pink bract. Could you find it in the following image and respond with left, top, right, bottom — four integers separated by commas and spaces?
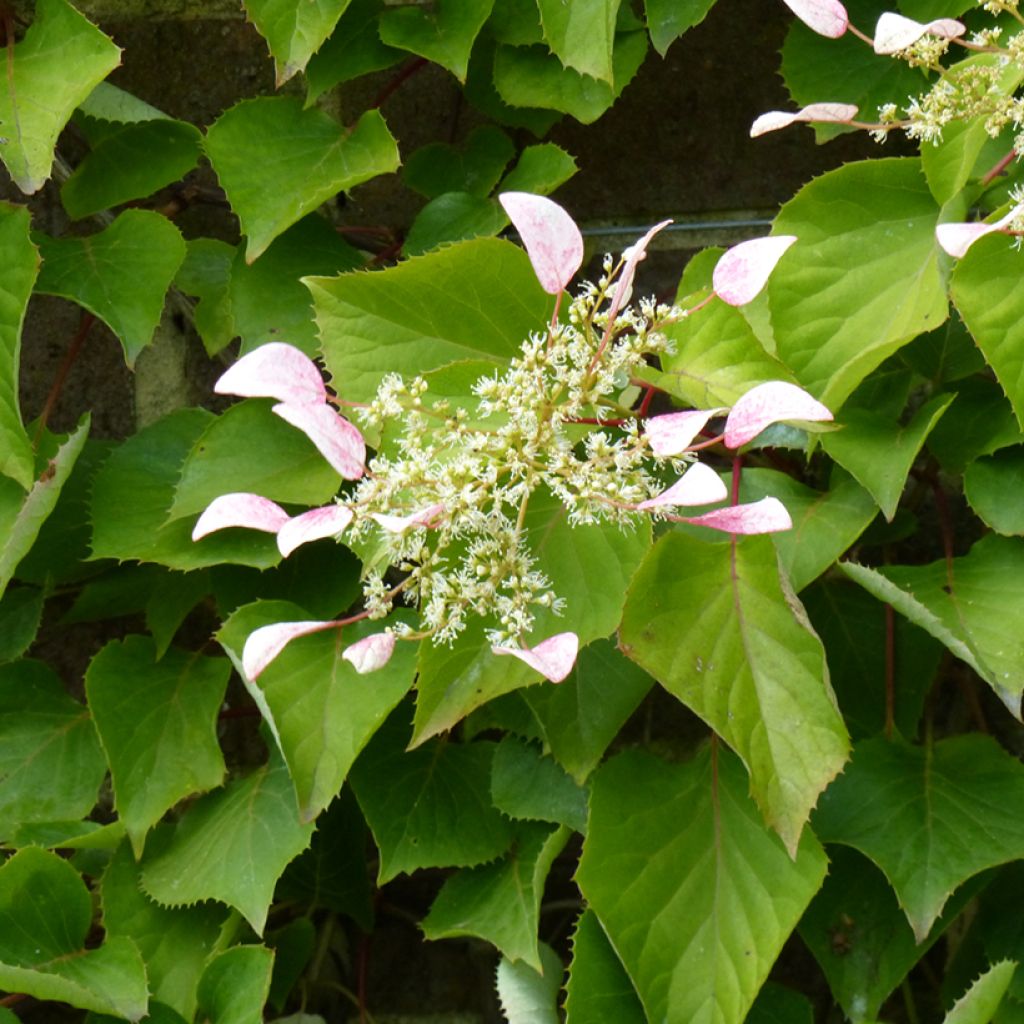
414, 495, 650, 743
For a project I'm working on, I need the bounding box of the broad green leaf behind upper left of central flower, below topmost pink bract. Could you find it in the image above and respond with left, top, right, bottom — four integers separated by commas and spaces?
306, 239, 552, 401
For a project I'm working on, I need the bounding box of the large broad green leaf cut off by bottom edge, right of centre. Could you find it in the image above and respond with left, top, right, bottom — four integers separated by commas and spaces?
577, 748, 826, 1024
